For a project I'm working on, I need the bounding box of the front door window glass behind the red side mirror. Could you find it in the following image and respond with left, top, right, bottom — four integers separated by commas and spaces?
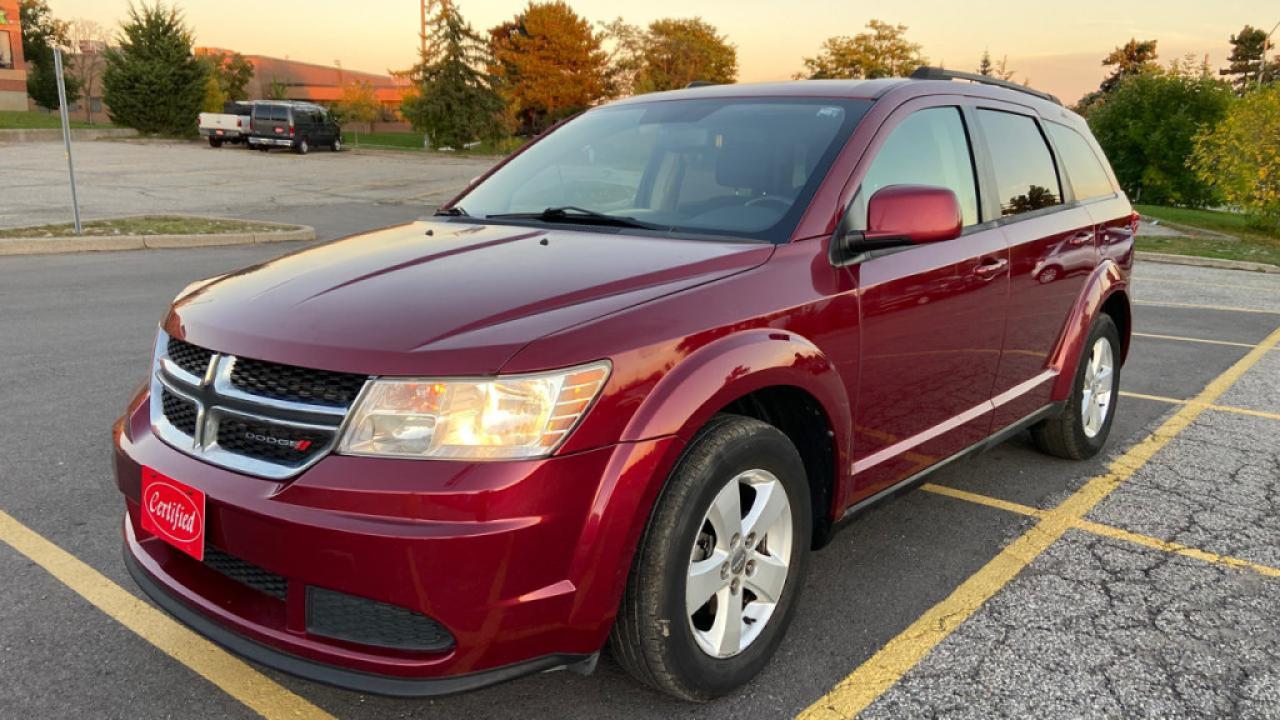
850, 108, 978, 229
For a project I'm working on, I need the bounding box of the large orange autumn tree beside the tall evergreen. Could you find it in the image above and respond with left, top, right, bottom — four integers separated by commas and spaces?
489, 0, 608, 132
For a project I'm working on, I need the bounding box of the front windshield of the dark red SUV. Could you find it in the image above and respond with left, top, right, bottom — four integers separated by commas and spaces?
456, 97, 870, 242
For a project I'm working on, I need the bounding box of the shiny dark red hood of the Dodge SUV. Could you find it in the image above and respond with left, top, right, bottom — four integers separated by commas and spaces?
164, 220, 773, 375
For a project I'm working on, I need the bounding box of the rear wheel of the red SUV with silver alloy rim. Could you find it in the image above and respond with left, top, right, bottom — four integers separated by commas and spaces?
1032, 314, 1120, 460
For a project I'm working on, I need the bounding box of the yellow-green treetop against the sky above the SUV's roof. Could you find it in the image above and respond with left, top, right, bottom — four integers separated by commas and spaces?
795, 19, 928, 79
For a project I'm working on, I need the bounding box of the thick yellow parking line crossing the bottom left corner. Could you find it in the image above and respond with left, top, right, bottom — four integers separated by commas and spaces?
0, 510, 332, 720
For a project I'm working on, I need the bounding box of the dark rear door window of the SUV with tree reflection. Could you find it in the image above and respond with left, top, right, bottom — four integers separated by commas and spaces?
978, 110, 1062, 215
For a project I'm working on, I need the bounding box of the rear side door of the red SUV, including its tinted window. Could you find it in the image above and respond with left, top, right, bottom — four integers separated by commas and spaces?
973, 101, 1098, 432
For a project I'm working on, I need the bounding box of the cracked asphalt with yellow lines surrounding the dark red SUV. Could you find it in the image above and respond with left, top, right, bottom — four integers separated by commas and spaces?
0, 142, 1280, 719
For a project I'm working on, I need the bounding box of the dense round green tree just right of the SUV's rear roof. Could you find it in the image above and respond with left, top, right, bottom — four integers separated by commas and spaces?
1088, 63, 1233, 208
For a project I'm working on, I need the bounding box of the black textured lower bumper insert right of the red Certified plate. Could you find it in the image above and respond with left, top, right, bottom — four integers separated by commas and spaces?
307, 587, 453, 652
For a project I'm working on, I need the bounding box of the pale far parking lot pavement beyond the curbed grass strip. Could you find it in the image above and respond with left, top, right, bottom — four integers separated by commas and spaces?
0, 141, 493, 240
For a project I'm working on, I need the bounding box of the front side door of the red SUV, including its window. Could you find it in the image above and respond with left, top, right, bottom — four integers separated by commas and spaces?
849, 97, 1009, 501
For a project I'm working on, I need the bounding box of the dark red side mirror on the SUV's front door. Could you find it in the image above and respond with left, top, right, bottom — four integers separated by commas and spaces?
844, 184, 964, 252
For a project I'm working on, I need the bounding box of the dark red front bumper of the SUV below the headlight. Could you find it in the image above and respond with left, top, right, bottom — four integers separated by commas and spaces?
114, 391, 678, 696
